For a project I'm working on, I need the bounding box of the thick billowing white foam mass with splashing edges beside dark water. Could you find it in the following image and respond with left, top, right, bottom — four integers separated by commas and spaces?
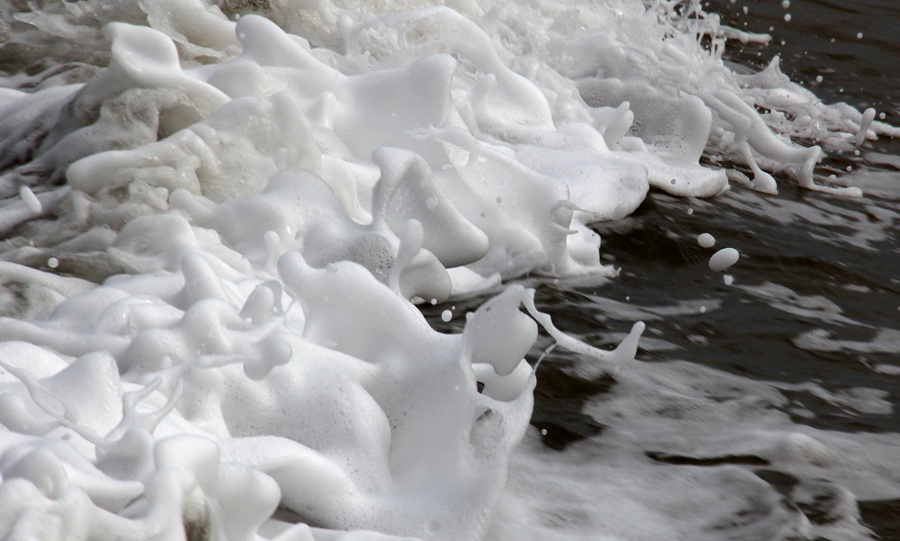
0, 0, 895, 540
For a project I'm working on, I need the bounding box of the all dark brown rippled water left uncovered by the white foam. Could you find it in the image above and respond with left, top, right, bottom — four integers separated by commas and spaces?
428, 0, 900, 539
